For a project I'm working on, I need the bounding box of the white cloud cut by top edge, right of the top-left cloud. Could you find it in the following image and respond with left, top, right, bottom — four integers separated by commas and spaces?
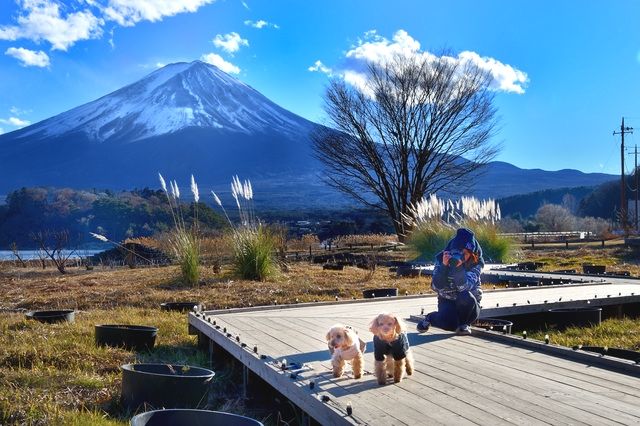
103, 0, 215, 27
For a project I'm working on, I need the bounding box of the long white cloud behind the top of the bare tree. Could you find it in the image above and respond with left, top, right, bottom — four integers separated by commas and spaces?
340, 30, 529, 94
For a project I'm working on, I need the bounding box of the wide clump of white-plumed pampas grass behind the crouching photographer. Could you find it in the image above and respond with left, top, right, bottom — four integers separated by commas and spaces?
405, 194, 514, 262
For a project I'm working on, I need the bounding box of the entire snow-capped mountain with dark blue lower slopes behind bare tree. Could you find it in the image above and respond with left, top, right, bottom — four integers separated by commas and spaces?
0, 61, 615, 208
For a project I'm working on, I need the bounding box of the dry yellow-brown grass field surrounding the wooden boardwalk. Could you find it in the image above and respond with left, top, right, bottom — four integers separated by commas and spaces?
0, 247, 640, 425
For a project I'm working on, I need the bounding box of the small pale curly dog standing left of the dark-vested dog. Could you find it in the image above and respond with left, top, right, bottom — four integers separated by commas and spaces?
327, 324, 367, 379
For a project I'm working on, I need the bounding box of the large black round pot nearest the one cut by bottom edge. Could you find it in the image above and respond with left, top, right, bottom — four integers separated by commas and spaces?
121, 364, 215, 410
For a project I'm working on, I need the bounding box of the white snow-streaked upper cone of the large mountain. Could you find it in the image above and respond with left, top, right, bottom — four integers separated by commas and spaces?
20, 61, 310, 142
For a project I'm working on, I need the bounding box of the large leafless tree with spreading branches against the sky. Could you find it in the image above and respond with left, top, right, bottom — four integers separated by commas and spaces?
312, 55, 498, 239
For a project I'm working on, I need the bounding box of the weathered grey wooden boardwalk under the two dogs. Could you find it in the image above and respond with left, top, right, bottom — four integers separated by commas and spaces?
189, 280, 640, 425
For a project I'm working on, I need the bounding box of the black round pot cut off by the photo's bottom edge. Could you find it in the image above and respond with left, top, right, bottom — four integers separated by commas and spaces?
131, 409, 262, 426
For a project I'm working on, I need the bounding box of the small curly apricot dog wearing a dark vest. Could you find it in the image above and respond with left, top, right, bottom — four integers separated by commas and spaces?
369, 313, 413, 385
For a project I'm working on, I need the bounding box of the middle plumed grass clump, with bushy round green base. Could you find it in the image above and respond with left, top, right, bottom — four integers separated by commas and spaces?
211, 176, 279, 281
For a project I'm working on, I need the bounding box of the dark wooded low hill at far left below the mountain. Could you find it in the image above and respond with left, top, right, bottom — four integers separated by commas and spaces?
0, 188, 223, 246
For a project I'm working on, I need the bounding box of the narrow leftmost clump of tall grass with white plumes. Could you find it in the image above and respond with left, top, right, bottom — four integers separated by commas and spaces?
158, 173, 200, 287
